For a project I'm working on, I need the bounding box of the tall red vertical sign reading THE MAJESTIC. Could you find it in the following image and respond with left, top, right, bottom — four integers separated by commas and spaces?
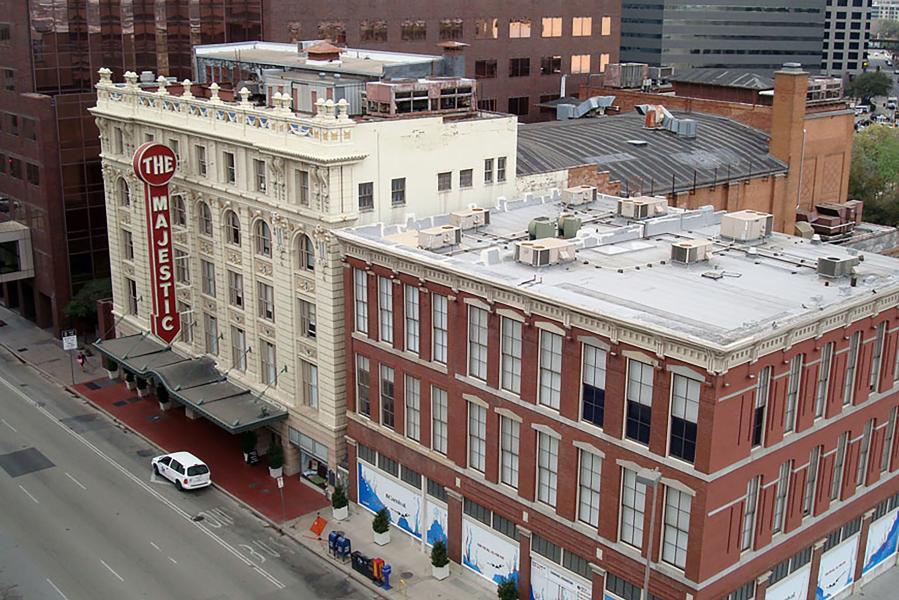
132, 142, 181, 344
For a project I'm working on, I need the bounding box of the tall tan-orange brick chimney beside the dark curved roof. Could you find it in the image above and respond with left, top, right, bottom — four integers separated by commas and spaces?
768, 63, 815, 235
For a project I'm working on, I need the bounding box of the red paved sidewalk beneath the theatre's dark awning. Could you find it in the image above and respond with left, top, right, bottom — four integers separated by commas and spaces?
75, 379, 328, 522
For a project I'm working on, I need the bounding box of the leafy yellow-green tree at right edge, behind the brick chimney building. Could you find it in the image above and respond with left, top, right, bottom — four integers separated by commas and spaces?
849, 125, 899, 226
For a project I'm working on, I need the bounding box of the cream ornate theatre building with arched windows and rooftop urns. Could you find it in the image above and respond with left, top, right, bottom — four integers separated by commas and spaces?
91, 69, 517, 482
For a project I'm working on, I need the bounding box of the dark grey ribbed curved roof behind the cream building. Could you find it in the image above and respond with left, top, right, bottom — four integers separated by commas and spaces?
518, 113, 787, 194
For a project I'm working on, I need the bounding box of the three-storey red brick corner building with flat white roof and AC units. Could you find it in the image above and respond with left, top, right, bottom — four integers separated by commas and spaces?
337, 198, 899, 600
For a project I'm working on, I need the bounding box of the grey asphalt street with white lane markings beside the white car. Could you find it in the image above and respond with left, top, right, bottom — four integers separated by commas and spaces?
0, 350, 373, 600
